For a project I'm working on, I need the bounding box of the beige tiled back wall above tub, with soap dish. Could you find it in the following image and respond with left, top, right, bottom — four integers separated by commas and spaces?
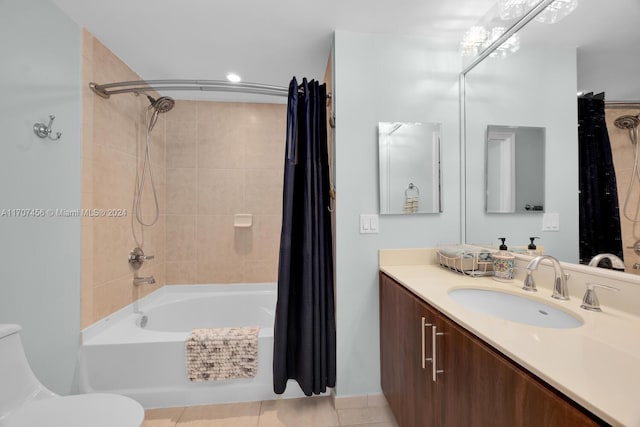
166, 101, 286, 284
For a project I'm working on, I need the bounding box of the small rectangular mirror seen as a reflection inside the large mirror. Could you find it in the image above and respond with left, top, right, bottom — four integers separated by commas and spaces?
485, 125, 545, 213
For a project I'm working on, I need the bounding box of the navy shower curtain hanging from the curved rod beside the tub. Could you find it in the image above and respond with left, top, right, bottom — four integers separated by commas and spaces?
273, 77, 336, 396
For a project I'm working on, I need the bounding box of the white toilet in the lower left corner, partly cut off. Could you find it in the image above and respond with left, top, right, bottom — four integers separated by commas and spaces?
0, 324, 144, 427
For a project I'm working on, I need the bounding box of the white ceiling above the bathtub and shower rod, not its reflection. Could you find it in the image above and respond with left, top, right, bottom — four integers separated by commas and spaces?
53, 0, 493, 101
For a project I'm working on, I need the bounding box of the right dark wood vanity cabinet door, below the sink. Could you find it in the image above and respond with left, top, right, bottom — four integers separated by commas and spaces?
436, 316, 601, 427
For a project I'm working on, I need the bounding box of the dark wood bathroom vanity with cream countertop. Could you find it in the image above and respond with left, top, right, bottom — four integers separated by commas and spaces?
380, 250, 640, 427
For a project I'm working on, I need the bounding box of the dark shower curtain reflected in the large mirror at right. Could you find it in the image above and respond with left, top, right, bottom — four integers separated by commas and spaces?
578, 93, 622, 264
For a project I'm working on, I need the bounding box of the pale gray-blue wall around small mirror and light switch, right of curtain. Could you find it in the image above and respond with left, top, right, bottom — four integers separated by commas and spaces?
334, 31, 461, 396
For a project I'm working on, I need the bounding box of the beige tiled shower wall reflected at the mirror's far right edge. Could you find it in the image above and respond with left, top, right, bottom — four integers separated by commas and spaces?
606, 104, 640, 274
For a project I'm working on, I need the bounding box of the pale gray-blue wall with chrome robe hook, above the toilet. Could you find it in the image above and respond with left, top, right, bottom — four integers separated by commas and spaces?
0, 0, 81, 394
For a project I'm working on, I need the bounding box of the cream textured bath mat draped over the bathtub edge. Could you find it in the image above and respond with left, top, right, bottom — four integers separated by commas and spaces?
186, 327, 260, 381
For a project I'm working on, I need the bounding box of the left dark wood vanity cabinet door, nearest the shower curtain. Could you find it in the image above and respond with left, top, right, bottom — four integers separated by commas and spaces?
380, 274, 435, 427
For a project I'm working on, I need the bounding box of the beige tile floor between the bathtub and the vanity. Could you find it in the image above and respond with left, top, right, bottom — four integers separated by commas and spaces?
144, 397, 397, 427
